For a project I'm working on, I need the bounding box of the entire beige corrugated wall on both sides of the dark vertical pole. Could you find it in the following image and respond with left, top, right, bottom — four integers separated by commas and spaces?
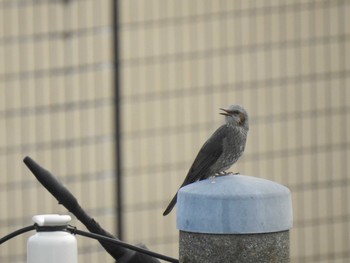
0, 0, 350, 263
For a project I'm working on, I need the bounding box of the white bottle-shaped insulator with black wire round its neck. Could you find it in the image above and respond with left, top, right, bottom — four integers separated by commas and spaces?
27, 215, 78, 263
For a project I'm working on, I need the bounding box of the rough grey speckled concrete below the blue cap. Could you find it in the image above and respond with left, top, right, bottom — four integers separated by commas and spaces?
180, 230, 290, 263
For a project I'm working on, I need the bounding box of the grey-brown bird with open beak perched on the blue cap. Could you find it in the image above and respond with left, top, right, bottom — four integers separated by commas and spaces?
163, 105, 249, 216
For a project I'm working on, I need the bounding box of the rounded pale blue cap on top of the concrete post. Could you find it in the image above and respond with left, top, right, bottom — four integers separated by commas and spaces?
176, 174, 293, 234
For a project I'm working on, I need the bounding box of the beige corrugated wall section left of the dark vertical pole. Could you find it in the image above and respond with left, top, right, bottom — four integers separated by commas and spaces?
0, 0, 115, 262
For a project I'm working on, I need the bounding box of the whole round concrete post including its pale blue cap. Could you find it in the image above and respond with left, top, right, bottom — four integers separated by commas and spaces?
177, 175, 293, 263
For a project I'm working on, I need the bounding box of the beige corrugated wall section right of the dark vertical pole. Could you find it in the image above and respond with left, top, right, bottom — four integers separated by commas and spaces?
120, 0, 350, 263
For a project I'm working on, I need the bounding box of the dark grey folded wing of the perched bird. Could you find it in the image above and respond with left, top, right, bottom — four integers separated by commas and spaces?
181, 125, 228, 187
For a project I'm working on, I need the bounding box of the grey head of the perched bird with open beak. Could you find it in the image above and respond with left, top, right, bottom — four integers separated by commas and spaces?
220, 105, 249, 130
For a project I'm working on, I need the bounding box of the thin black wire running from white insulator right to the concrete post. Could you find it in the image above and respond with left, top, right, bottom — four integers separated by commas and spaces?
67, 226, 179, 263
